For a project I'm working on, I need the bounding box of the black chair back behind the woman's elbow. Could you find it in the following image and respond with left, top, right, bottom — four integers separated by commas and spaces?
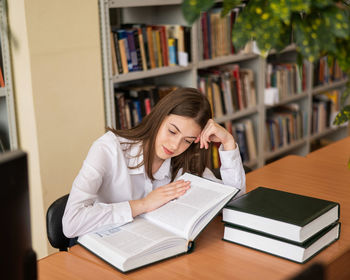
46, 194, 71, 251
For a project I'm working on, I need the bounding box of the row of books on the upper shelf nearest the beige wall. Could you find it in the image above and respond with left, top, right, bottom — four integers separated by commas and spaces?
110, 24, 191, 75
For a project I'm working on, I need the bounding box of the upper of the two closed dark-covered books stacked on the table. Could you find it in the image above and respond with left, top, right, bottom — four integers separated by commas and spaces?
222, 187, 340, 243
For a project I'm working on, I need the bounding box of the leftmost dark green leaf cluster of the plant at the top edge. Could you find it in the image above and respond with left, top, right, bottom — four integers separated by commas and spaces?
181, 0, 215, 25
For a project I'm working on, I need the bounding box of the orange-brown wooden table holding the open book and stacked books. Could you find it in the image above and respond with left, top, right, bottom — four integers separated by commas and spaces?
39, 138, 350, 280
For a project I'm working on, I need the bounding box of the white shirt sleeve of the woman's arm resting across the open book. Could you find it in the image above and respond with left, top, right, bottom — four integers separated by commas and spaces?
62, 137, 133, 238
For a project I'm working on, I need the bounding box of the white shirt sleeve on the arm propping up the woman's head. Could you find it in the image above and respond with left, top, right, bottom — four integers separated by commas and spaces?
203, 144, 246, 196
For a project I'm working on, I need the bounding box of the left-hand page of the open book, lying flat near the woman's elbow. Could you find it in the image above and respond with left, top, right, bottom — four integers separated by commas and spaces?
78, 217, 185, 261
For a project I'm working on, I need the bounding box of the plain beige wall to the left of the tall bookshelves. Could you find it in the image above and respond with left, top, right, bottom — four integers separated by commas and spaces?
8, 0, 105, 258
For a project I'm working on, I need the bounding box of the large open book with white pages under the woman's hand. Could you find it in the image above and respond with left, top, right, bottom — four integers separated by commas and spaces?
78, 173, 239, 272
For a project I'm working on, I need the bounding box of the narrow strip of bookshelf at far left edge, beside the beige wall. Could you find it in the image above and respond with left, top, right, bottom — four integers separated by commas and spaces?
0, 0, 17, 152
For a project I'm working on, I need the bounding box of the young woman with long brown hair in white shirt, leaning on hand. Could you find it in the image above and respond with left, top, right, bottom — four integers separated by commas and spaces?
63, 88, 245, 237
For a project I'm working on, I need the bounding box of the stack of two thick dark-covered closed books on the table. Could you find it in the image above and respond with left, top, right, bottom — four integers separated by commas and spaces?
223, 187, 340, 263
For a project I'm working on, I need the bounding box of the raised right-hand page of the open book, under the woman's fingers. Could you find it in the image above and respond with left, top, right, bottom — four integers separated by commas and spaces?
144, 173, 239, 240
